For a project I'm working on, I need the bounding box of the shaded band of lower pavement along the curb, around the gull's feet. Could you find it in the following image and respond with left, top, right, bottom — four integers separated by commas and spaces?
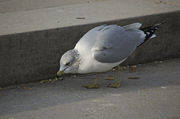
0, 62, 180, 116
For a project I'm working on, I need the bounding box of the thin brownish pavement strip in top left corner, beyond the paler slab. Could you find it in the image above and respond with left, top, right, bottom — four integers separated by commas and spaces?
0, 0, 88, 13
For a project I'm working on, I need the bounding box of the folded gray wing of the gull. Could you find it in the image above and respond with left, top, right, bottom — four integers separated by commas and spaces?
92, 25, 145, 63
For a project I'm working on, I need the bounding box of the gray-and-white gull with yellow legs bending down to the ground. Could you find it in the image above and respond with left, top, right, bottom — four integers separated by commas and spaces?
57, 23, 161, 88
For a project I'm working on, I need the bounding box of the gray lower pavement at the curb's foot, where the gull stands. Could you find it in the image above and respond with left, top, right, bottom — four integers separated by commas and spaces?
0, 59, 180, 119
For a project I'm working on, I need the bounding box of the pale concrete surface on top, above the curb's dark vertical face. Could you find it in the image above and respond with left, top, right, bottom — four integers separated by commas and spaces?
0, 0, 180, 35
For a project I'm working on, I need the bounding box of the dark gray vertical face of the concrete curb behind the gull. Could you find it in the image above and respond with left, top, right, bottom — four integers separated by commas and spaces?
0, 11, 180, 86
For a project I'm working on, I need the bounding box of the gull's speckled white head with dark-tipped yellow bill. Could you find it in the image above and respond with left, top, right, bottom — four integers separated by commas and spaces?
57, 49, 79, 76
